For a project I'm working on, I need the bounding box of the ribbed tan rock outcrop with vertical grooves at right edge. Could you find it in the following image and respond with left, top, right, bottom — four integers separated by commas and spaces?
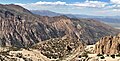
95, 34, 120, 54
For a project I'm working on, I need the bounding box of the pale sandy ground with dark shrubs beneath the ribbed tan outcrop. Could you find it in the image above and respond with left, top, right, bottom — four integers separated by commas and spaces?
74, 45, 120, 61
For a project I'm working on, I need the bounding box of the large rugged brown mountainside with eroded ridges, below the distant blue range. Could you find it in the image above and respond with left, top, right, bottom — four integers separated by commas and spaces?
0, 4, 118, 47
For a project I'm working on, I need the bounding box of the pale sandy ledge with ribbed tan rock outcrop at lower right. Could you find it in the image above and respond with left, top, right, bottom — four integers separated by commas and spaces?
75, 34, 120, 61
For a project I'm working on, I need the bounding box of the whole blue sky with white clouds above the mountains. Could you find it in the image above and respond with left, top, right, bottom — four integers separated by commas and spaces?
0, 0, 120, 16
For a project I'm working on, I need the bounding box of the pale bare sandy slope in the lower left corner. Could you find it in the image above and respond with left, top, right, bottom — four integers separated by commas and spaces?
0, 47, 50, 61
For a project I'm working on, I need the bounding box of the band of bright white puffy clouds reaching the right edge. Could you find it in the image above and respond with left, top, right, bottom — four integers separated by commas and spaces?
16, 0, 120, 9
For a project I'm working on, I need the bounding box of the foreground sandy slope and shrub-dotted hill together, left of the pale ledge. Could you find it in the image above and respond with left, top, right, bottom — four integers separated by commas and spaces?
0, 38, 84, 61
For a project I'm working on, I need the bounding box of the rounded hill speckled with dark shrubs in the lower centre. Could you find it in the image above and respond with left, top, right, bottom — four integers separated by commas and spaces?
32, 38, 80, 59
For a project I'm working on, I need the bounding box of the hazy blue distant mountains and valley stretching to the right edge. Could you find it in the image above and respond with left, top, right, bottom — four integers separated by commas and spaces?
31, 10, 120, 28
